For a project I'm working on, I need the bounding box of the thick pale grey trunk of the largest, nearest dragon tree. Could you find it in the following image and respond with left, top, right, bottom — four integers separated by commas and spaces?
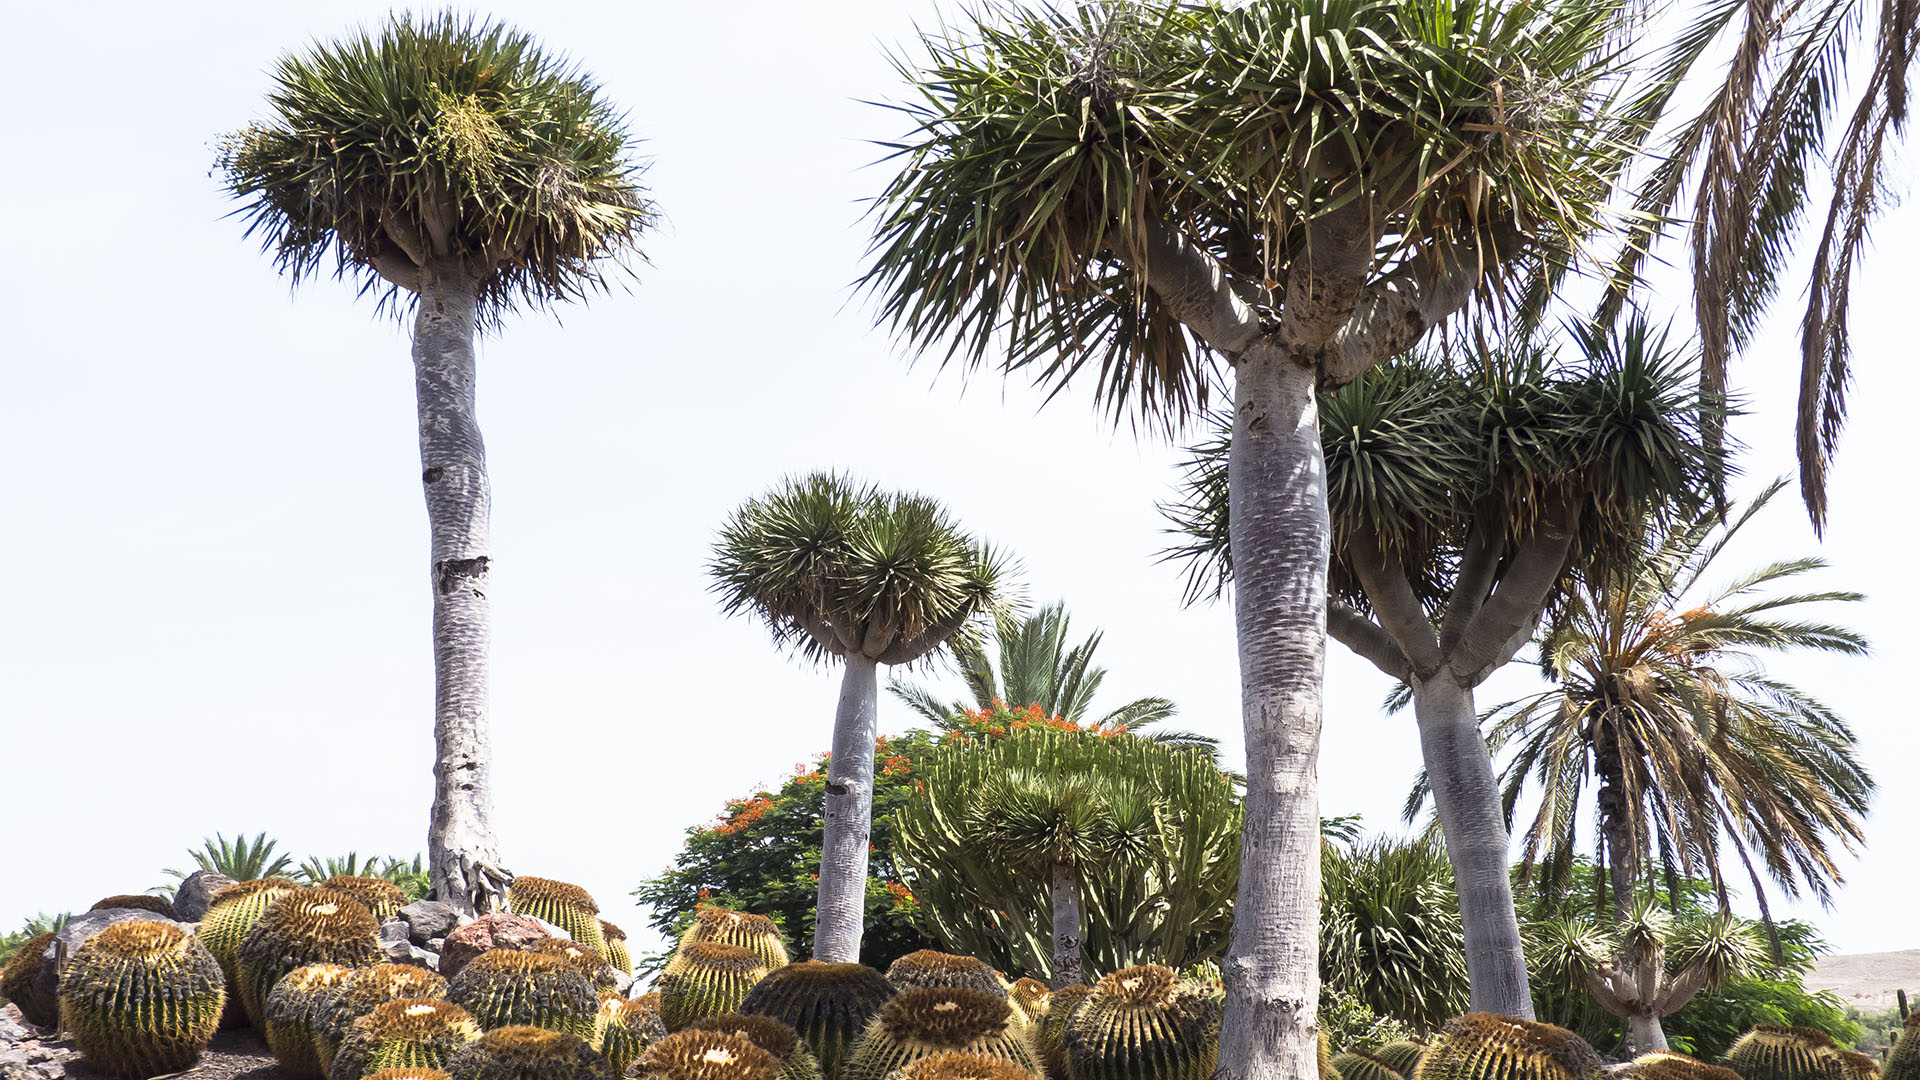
1215, 352, 1329, 1080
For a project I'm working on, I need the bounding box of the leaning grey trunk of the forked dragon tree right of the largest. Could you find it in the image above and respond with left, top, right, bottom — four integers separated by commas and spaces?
1413, 669, 1534, 1020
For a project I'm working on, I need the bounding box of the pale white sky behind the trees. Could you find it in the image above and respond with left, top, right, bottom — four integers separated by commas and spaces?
0, 0, 1920, 951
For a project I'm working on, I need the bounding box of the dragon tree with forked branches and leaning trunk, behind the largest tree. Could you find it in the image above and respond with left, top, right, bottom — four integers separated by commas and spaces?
1167, 321, 1718, 1015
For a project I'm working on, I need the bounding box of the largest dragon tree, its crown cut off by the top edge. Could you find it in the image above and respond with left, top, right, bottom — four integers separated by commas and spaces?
864, 0, 1632, 1053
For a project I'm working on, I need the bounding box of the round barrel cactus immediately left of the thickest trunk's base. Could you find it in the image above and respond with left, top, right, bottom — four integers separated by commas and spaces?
1062, 965, 1219, 1080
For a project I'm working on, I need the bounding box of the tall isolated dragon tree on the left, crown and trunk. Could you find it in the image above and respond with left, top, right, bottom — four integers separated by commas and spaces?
219, 15, 653, 911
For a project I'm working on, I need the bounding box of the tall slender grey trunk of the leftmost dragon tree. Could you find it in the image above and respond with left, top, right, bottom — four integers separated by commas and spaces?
413, 267, 511, 913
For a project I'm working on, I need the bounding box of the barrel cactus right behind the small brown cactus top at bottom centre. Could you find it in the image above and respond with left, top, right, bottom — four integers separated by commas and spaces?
841, 986, 1039, 1080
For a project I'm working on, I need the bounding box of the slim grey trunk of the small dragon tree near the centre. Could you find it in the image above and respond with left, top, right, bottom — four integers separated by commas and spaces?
814, 651, 879, 963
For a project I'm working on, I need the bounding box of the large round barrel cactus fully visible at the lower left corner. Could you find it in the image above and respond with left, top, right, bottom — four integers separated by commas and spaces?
60, 919, 227, 1078
